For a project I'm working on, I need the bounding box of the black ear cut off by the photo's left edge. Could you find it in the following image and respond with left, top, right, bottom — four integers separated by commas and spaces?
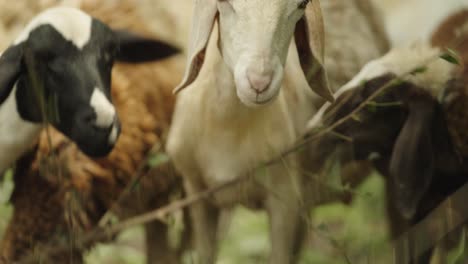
0, 45, 23, 104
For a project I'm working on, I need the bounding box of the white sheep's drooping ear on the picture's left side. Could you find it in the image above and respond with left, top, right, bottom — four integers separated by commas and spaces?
174, 0, 218, 93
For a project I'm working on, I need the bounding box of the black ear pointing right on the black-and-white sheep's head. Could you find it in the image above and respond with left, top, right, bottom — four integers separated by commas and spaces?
114, 30, 179, 63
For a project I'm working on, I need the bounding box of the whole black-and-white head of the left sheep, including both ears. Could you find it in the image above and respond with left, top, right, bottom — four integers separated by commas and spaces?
0, 8, 176, 156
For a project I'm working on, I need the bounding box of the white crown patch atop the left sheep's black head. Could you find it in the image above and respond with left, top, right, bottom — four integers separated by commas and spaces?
13, 7, 92, 49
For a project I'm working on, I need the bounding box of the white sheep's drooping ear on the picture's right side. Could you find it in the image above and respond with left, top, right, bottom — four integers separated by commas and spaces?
294, 0, 334, 102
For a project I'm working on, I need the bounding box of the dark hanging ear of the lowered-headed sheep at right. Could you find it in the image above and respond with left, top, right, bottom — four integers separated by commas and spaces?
389, 99, 436, 219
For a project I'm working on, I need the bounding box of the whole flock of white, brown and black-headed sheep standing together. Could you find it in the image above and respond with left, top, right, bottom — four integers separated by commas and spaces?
0, 0, 468, 264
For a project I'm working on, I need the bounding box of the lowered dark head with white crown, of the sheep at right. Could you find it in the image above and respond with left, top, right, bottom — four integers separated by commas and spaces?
309, 46, 463, 219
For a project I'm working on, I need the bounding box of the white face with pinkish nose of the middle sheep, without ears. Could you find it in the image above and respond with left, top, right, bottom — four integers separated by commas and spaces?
218, 0, 305, 106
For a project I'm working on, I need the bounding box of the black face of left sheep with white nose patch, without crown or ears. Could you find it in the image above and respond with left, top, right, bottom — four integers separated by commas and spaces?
17, 20, 120, 156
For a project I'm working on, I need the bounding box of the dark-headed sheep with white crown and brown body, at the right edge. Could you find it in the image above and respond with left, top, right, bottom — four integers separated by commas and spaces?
309, 8, 468, 263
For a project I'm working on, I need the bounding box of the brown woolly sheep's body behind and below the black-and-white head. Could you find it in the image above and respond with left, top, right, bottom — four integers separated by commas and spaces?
0, 0, 185, 264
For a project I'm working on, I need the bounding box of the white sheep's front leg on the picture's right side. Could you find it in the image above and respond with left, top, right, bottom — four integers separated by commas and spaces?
266, 163, 305, 264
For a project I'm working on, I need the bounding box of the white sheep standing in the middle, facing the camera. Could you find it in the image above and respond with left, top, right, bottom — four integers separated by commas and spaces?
167, 0, 333, 264
